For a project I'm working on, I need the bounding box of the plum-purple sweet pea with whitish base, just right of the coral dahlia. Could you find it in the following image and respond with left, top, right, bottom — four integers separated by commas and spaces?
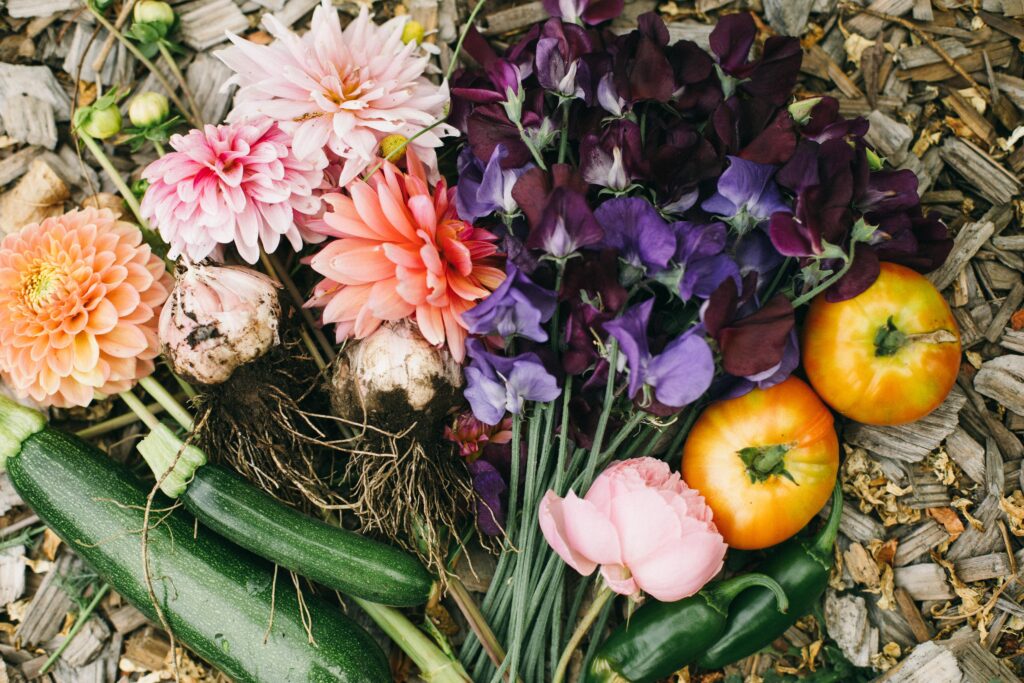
526, 187, 604, 259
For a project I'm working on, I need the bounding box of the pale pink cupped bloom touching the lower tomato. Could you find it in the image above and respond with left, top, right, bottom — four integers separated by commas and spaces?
540, 458, 726, 602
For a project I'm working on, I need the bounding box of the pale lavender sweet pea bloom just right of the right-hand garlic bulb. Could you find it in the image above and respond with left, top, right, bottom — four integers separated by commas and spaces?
464, 339, 561, 425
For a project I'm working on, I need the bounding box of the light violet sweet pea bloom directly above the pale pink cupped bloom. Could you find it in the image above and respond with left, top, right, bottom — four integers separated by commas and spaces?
604, 299, 715, 408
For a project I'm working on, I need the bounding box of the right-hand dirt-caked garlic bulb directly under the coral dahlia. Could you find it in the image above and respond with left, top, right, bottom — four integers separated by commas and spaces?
331, 321, 462, 430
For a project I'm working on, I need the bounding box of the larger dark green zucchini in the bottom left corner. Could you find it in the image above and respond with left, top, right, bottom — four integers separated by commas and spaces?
0, 398, 391, 683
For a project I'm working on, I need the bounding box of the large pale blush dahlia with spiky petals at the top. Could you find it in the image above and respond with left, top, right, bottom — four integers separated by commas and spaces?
217, 0, 457, 186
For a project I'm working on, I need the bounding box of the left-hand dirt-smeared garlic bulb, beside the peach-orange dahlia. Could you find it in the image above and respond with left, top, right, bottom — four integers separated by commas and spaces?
160, 265, 281, 385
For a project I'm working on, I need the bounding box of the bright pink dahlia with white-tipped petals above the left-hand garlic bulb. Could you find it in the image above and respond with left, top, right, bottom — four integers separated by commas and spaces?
142, 120, 323, 263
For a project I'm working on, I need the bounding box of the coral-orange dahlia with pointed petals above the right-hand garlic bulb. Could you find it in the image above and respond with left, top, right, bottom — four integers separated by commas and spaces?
306, 153, 505, 362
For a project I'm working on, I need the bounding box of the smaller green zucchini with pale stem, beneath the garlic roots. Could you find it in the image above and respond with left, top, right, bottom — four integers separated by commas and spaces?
138, 425, 434, 607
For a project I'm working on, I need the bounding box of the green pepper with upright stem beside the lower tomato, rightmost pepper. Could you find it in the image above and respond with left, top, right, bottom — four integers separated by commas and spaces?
697, 482, 843, 669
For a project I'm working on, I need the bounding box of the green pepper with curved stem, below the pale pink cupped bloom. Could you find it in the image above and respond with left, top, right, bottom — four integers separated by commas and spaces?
584, 573, 787, 683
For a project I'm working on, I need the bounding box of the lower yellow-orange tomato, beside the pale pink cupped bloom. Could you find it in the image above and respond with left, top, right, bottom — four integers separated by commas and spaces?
683, 377, 839, 550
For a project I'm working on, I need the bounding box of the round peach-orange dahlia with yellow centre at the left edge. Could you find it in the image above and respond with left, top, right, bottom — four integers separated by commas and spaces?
0, 209, 171, 408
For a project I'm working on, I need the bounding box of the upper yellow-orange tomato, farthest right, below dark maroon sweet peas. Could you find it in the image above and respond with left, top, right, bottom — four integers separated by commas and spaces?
801, 263, 961, 425
